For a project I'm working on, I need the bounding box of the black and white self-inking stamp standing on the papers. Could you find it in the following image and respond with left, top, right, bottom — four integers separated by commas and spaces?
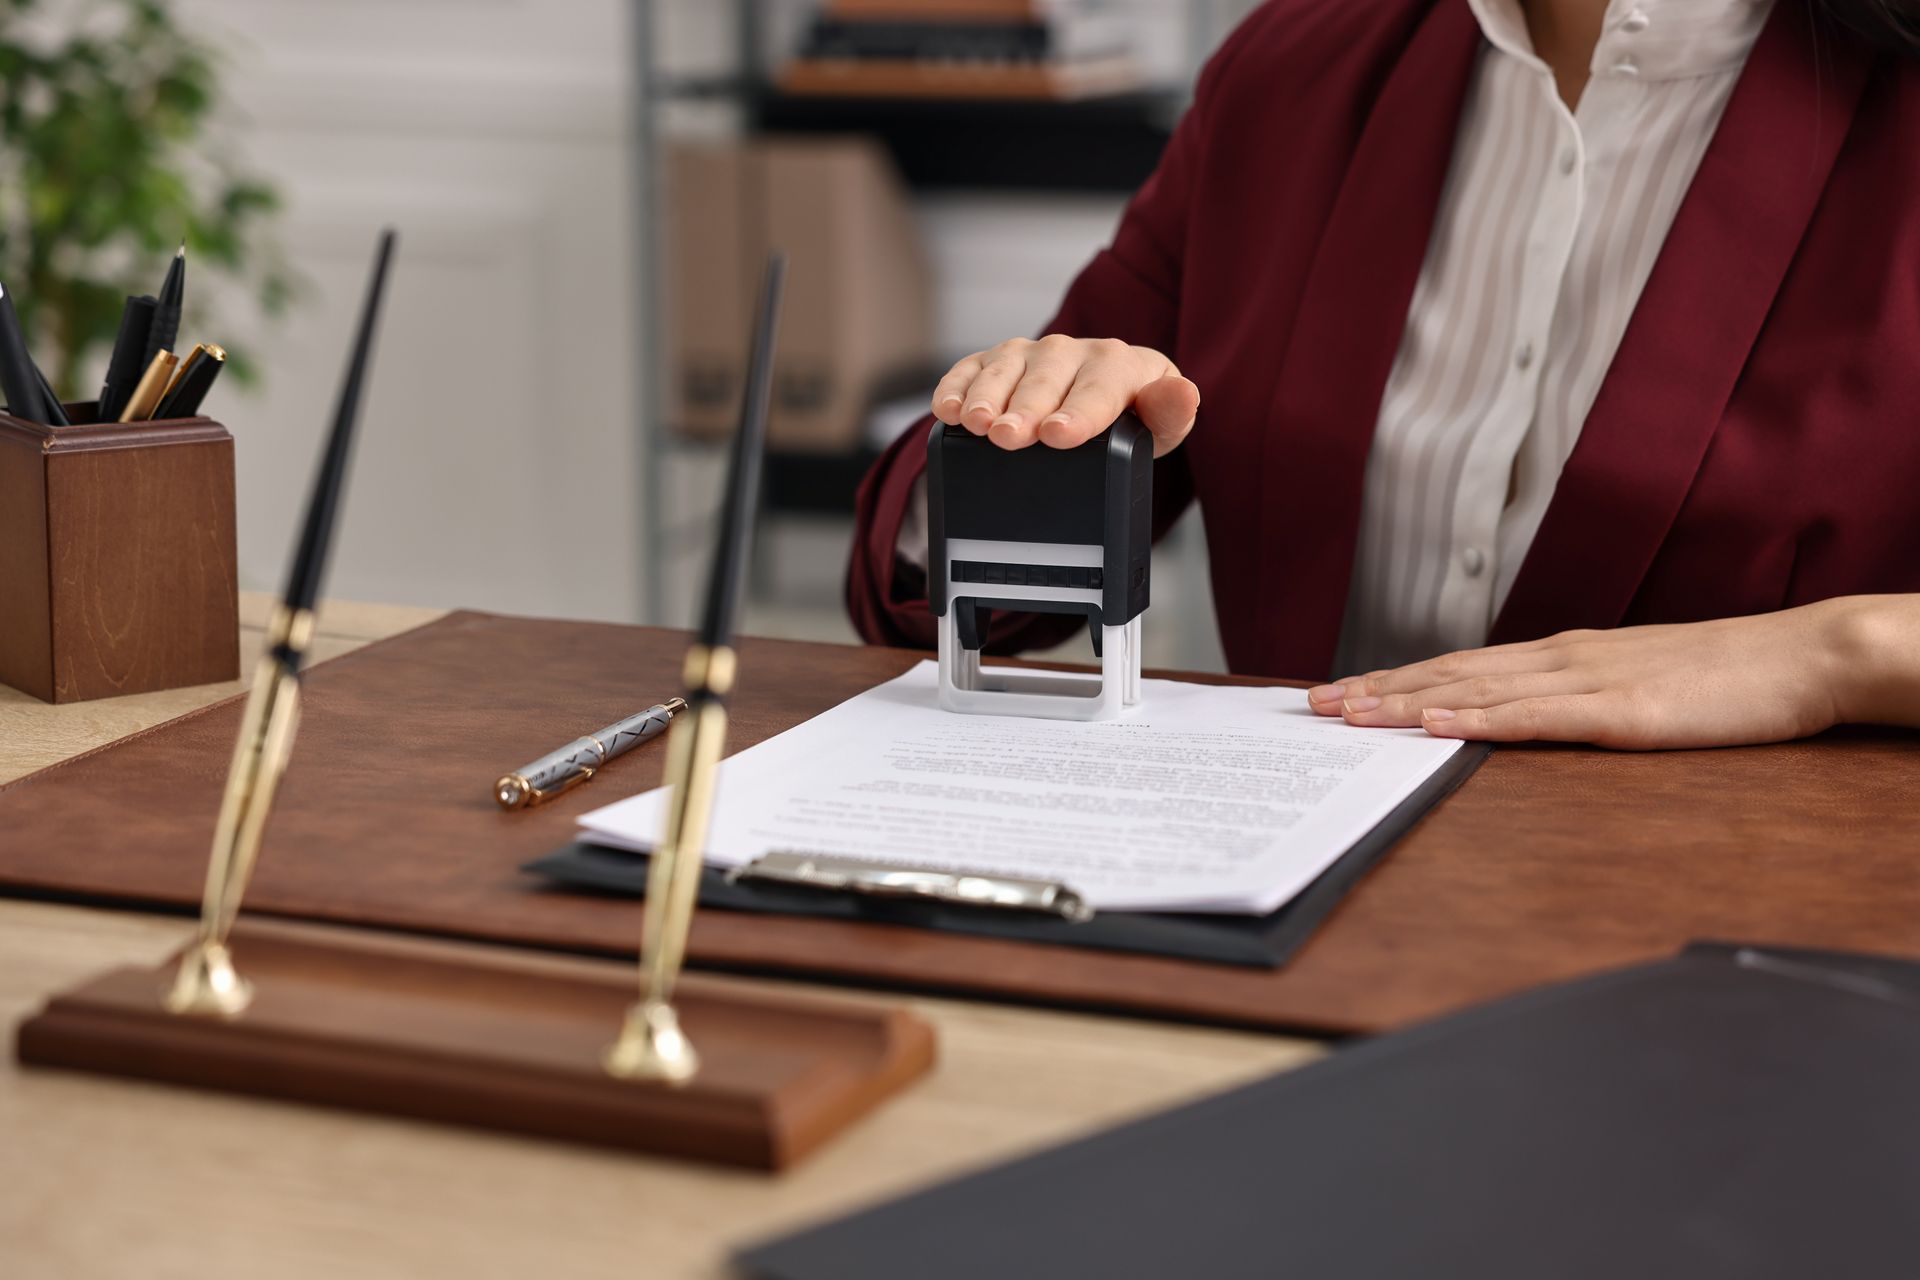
927, 413, 1154, 720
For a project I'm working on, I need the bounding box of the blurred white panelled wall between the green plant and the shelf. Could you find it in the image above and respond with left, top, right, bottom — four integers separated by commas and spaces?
166, 0, 641, 618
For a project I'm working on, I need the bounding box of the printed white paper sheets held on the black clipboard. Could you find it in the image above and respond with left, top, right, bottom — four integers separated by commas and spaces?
580, 662, 1459, 913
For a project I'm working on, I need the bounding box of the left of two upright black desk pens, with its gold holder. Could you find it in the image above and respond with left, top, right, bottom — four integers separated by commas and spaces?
167, 230, 394, 1017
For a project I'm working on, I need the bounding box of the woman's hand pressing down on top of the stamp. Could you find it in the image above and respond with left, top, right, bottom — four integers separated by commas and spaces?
933, 334, 1200, 457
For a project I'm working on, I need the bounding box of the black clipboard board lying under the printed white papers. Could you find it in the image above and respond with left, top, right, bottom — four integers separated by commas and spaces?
522, 743, 1490, 969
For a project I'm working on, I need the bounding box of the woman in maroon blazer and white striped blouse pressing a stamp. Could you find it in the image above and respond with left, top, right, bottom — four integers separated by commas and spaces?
847, 0, 1920, 747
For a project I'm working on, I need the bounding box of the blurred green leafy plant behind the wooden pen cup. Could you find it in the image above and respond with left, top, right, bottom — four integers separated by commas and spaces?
0, 0, 300, 399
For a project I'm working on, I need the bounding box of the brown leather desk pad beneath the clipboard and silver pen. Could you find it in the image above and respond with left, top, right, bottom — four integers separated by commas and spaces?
0, 612, 1920, 1034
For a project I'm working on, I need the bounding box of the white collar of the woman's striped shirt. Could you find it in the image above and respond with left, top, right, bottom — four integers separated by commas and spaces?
1467, 0, 1772, 81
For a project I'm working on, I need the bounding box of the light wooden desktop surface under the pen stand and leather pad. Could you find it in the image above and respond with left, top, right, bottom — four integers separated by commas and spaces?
0, 597, 1321, 1280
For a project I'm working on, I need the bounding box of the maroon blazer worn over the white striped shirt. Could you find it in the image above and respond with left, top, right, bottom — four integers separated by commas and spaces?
847, 0, 1920, 677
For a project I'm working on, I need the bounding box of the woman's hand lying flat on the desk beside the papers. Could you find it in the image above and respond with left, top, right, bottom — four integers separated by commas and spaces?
1308, 595, 1920, 750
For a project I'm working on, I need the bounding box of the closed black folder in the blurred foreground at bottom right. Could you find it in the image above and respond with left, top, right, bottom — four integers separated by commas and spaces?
739, 946, 1920, 1280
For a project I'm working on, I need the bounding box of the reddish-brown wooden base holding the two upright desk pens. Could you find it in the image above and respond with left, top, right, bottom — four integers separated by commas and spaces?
17, 923, 933, 1171
